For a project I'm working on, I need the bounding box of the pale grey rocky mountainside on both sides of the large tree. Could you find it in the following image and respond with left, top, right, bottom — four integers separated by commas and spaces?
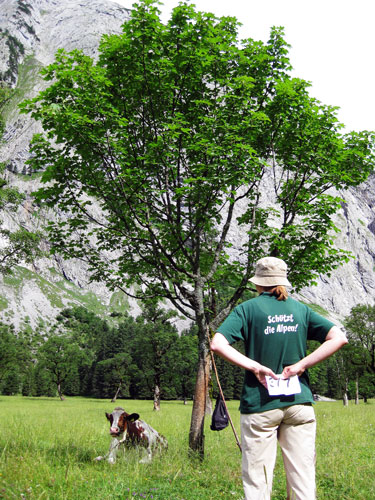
0, 0, 375, 327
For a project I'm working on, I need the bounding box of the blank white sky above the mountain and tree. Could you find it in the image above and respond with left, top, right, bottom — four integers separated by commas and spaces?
115, 0, 375, 131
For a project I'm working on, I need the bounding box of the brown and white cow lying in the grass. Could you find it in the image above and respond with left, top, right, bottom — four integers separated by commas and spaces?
95, 407, 168, 464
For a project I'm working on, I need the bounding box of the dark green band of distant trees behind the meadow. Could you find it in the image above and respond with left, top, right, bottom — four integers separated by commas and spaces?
0, 307, 350, 401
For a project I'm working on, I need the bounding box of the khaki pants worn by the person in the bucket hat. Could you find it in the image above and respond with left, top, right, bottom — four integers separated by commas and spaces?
241, 404, 316, 500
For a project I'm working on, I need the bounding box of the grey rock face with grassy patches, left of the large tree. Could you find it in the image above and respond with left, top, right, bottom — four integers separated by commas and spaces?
0, 0, 132, 327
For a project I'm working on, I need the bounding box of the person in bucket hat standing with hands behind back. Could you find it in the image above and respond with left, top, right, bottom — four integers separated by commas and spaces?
210, 257, 347, 500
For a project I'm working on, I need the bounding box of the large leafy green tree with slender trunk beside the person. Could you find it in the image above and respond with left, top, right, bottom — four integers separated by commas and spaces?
23, 0, 373, 454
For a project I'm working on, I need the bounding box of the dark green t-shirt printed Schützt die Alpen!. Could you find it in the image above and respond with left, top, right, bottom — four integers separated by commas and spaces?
217, 293, 334, 413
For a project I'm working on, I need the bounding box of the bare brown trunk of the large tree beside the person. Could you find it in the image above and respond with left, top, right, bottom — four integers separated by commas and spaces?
189, 349, 211, 459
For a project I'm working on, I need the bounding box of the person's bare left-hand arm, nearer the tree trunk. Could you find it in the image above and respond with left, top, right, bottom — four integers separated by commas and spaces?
210, 332, 277, 388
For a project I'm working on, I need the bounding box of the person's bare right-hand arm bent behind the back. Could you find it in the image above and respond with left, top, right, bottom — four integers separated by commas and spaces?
282, 326, 348, 379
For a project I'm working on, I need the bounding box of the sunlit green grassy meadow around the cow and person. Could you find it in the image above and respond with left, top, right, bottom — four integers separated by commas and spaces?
0, 396, 375, 500
